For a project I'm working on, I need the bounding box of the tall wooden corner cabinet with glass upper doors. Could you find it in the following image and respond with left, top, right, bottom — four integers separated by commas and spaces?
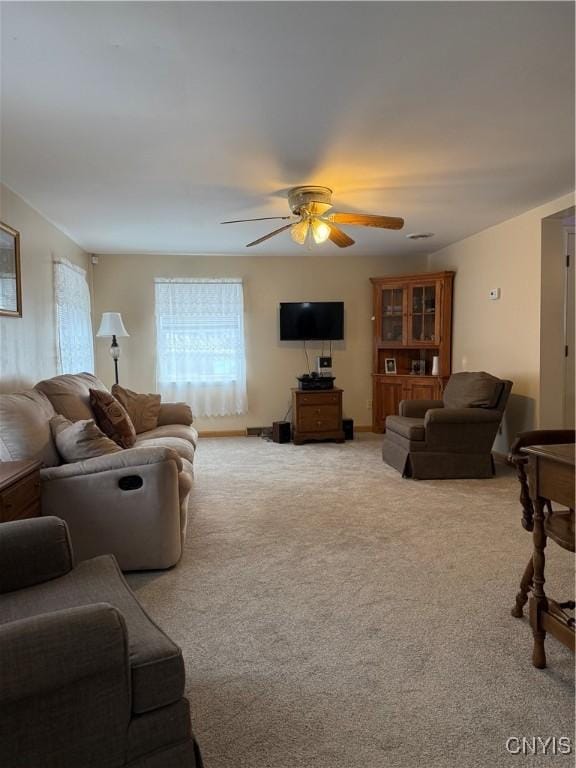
371, 272, 454, 432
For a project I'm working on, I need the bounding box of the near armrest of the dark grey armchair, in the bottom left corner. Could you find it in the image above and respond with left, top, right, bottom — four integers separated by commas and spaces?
0, 603, 130, 766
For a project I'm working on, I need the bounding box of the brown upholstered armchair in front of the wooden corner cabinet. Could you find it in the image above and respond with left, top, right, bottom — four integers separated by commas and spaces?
382, 372, 512, 480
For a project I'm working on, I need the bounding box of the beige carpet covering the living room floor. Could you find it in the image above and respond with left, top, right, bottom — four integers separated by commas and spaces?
130, 435, 574, 768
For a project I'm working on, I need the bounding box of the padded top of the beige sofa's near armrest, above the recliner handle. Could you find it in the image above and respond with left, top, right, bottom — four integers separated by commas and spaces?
40, 446, 182, 481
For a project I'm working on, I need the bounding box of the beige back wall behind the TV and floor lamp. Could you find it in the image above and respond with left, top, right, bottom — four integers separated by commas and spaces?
93, 251, 425, 430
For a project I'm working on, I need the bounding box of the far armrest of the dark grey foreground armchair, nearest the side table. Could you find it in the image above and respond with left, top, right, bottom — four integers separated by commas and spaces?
0, 517, 73, 594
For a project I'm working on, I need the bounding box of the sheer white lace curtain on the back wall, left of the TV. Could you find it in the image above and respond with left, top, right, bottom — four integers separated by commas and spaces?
155, 279, 247, 416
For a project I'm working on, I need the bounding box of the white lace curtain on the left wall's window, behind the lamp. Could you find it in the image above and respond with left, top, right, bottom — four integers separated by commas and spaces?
54, 259, 94, 373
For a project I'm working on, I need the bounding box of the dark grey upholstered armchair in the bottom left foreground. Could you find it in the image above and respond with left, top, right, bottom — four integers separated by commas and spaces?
0, 517, 202, 768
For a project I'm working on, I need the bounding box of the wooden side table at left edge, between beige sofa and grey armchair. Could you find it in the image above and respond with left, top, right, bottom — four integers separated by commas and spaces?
0, 460, 42, 523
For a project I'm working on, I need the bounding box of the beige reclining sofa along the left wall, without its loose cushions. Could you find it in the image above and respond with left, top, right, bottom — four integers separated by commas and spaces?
0, 373, 198, 571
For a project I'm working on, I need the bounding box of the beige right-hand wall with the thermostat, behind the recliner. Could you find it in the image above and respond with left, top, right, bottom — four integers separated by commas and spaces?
428, 190, 574, 450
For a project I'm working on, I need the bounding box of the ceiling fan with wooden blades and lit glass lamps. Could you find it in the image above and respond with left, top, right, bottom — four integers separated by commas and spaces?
221, 186, 404, 248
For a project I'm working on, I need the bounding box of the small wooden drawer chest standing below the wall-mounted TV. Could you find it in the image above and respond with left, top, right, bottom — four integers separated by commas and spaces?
292, 387, 344, 445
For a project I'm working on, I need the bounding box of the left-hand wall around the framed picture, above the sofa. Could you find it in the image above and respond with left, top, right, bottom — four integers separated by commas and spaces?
0, 185, 89, 392
